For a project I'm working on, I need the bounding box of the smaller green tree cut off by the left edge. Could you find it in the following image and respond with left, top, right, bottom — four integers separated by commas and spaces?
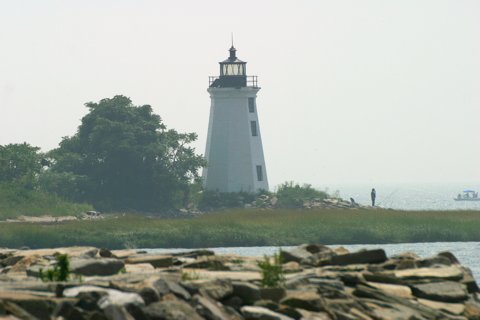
0, 143, 46, 189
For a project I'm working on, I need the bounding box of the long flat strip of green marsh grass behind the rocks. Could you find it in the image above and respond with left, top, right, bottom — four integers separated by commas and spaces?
0, 209, 480, 248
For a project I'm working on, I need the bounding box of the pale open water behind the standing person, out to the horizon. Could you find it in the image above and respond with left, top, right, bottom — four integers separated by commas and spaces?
322, 183, 480, 210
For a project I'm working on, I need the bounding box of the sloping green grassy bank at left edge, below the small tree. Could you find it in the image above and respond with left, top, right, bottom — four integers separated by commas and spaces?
0, 184, 92, 220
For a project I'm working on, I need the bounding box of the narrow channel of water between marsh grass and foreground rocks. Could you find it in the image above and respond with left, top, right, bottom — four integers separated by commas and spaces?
147, 242, 480, 282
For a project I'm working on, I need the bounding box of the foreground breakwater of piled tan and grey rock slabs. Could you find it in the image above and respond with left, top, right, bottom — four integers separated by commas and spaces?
0, 244, 480, 320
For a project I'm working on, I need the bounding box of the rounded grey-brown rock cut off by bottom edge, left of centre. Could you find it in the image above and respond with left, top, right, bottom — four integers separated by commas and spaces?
143, 300, 202, 320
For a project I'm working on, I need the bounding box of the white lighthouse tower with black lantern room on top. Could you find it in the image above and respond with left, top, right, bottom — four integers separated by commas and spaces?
203, 44, 268, 193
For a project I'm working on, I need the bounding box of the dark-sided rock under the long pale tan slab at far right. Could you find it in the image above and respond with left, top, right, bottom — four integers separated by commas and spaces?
412, 281, 468, 302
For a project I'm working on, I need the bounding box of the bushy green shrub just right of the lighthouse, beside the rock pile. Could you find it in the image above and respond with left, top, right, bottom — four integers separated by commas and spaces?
276, 181, 328, 208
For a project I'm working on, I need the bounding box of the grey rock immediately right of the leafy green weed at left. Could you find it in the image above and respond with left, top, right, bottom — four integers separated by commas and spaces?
70, 258, 124, 276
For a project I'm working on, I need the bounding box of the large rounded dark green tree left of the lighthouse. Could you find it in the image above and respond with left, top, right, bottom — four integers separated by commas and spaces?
45, 96, 205, 212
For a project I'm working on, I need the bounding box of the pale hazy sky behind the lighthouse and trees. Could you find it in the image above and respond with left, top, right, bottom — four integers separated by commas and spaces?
0, 0, 480, 186
